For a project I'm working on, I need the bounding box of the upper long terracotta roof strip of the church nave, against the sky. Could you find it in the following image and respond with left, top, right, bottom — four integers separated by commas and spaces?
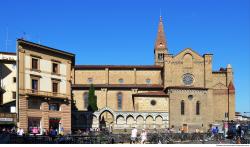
75, 65, 163, 70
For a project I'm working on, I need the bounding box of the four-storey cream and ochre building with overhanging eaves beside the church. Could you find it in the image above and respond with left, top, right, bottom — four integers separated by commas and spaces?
16, 39, 75, 134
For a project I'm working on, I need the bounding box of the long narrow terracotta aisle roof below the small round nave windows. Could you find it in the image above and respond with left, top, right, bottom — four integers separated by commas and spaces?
71, 84, 163, 90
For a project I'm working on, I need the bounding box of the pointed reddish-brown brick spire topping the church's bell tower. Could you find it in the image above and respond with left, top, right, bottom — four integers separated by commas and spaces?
155, 16, 167, 50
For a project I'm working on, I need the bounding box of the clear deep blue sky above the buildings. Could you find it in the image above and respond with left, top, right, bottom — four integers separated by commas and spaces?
0, 0, 250, 112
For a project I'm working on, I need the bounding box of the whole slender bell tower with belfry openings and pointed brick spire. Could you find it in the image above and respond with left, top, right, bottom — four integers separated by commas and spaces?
154, 16, 168, 65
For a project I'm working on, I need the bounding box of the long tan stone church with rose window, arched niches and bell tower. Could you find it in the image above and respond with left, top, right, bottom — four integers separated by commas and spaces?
71, 18, 235, 132
